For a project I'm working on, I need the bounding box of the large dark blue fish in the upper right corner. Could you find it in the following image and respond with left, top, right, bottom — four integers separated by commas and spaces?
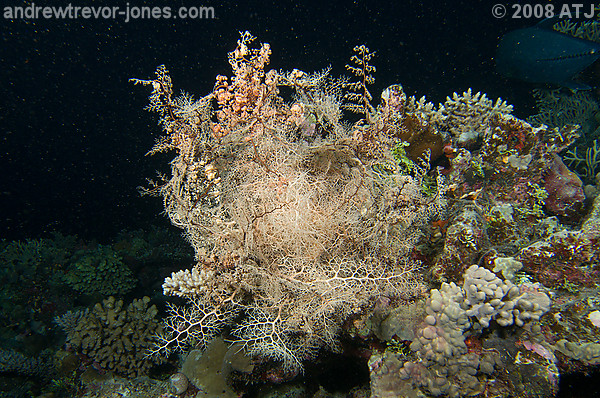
496, 18, 600, 90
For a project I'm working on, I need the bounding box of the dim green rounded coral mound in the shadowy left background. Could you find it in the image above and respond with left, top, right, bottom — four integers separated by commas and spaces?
65, 245, 136, 296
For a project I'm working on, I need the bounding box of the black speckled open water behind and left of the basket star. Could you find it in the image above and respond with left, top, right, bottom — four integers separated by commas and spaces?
0, 0, 538, 241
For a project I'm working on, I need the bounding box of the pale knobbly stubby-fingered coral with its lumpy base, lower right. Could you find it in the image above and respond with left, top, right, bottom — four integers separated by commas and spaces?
369, 265, 550, 397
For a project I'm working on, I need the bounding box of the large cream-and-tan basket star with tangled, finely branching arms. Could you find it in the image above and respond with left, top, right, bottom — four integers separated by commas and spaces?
134, 33, 445, 374
